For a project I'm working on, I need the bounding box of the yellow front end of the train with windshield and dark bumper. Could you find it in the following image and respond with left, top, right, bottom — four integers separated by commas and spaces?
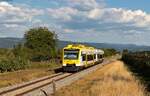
62, 45, 83, 72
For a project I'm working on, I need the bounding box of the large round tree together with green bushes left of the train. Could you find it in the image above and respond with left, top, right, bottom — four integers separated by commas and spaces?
0, 27, 57, 72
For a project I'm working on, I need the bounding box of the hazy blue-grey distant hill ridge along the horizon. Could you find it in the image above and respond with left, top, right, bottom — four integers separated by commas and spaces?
0, 38, 150, 51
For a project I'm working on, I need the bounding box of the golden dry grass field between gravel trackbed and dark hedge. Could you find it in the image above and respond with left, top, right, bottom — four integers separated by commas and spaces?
56, 61, 145, 96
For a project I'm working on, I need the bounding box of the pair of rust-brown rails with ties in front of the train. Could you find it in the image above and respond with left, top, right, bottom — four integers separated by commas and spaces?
0, 73, 72, 96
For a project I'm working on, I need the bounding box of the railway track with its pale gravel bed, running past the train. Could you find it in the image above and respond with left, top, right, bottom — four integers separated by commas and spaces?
0, 60, 110, 96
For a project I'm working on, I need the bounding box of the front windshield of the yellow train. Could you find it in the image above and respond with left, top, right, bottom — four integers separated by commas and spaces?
64, 49, 79, 59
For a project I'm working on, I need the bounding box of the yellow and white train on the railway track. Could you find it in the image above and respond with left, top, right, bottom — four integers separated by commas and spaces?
62, 44, 104, 72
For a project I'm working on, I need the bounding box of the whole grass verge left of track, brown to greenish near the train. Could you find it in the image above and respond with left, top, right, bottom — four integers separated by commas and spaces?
0, 61, 61, 88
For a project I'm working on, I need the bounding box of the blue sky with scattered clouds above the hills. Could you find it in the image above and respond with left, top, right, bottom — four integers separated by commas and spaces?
0, 0, 150, 46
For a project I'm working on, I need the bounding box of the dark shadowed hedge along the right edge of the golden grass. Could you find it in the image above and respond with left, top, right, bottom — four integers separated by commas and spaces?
122, 50, 150, 91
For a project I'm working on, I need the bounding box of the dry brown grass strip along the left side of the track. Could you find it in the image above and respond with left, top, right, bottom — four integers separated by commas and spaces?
0, 69, 52, 88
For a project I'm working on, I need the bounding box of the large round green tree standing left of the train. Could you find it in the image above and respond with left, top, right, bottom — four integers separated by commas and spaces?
24, 27, 57, 61
